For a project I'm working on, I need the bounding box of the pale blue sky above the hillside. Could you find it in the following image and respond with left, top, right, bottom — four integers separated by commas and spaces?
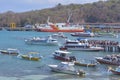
0, 0, 99, 13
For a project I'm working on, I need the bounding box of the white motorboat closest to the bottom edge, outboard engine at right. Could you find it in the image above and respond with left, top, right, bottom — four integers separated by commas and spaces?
48, 62, 85, 75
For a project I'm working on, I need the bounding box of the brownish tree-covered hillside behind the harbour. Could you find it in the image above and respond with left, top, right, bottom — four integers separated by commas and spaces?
0, 0, 120, 27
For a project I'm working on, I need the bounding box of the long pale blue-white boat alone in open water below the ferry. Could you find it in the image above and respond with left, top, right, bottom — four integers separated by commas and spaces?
25, 36, 58, 45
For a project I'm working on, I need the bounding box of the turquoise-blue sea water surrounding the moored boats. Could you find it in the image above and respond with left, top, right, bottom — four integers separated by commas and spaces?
0, 30, 120, 80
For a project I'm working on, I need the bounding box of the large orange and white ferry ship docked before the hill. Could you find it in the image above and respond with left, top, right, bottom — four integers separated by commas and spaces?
36, 17, 84, 32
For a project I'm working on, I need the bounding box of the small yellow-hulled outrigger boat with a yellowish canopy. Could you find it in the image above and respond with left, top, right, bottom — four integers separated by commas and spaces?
17, 52, 41, 61
